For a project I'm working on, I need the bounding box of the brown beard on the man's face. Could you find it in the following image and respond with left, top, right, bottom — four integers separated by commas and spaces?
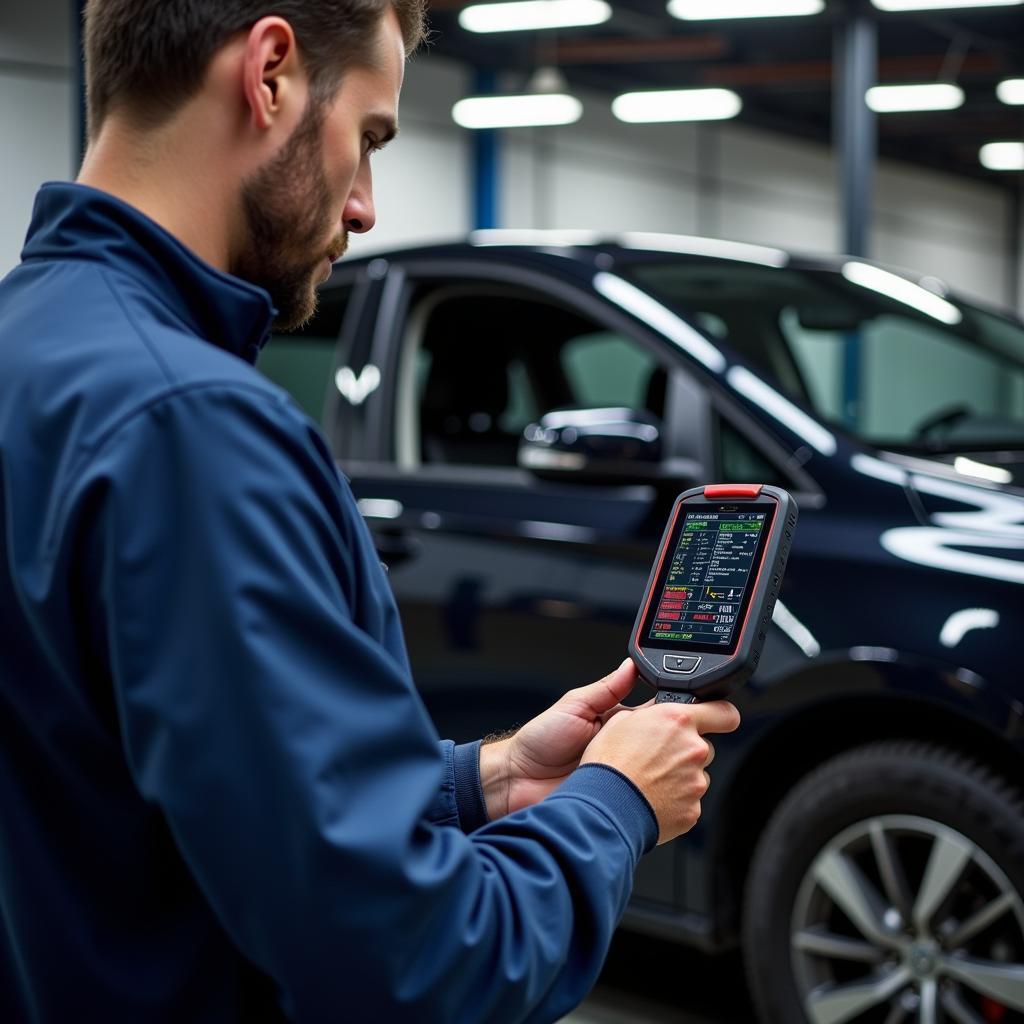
231, 103, 348, 331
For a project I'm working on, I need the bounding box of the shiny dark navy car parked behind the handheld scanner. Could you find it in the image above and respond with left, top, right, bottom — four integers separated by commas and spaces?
261, 231, 1024, 1024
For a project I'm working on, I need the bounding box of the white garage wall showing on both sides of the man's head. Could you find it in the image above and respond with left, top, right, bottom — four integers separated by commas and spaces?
0, 18, 1024, 315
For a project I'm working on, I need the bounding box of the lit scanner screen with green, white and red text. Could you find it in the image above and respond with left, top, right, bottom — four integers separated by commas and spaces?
648, 512, 765, 646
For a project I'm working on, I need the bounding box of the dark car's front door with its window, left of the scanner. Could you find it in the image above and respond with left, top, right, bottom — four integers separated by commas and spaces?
345, 256, 704, 739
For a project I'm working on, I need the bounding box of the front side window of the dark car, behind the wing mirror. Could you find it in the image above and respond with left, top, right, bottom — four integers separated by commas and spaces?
396, 284, 666, 466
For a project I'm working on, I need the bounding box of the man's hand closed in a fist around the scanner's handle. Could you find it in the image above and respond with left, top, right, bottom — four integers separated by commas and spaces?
583, 700, 739, 844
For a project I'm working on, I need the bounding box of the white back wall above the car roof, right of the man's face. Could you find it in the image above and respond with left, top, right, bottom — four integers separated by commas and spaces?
353, 56, 1013, 305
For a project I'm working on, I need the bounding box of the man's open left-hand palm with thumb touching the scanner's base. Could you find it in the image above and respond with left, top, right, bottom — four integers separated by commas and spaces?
480, 658, 637, 820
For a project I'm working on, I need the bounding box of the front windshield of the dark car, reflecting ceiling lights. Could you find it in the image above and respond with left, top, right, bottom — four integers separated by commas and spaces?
623, 256, 1024, 453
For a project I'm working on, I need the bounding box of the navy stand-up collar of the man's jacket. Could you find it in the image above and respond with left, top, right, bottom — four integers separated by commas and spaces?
22, 181, 276, 362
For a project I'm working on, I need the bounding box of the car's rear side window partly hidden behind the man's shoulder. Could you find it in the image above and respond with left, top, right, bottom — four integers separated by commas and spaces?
257, 287, 352, 423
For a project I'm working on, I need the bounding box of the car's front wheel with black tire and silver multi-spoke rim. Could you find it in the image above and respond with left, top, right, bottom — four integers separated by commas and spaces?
743, 741, 1024, 1024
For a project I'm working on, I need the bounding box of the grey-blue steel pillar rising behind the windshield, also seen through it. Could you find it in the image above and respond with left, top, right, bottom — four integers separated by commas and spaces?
833, 3, 879, 427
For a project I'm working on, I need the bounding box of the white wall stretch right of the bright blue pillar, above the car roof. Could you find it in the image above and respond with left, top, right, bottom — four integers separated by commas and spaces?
493, 74, 1012, 304
